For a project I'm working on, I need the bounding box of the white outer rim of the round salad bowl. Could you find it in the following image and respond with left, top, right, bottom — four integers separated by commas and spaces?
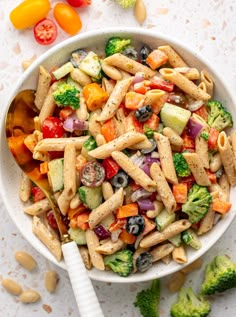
0, 27, 236, 283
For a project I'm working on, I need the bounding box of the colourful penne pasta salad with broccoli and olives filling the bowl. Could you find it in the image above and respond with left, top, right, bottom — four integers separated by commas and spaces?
12, 37, 236, 277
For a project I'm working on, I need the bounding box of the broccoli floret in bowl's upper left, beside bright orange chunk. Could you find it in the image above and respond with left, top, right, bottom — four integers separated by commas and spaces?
53, 82, 79, 109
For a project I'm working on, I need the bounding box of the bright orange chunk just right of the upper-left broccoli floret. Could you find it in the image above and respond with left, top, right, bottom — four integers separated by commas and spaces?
83, 83, 109, 111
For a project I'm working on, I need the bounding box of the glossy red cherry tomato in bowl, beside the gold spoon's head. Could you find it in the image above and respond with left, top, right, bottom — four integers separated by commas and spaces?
42, 117, 65, 138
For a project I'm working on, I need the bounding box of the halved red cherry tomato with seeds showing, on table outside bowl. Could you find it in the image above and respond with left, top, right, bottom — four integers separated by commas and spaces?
34, 19, 57, 45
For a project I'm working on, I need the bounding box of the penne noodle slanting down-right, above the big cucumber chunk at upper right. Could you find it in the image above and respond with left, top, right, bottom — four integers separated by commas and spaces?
159, 68, 211, 101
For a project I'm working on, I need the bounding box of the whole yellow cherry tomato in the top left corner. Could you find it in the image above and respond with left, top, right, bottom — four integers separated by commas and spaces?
10, 0, 50, 30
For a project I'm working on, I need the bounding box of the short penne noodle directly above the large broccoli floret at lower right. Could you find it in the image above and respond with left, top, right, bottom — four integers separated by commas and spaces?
183, 152, 211, 186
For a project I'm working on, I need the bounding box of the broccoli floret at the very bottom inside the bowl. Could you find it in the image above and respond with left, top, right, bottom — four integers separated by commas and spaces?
104, 250, 133, 277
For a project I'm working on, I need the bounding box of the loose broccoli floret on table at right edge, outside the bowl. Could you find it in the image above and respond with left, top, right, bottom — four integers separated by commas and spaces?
201, 255, 236, 295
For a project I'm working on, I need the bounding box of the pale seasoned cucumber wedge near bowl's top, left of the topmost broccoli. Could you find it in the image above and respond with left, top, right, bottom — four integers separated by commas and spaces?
79, 51, 102, 79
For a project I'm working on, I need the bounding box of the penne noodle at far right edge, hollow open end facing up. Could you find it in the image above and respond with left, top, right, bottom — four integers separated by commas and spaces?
217, 131, 236, 186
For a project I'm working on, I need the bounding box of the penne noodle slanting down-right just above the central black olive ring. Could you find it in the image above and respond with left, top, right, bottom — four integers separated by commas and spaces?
111, 151, 156, 192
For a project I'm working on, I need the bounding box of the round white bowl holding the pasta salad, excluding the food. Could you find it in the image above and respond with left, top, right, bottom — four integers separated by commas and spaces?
0, 28, 236, 283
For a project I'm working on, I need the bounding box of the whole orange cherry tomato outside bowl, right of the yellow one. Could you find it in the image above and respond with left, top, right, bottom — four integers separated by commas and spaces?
53, 3, 82, 35
